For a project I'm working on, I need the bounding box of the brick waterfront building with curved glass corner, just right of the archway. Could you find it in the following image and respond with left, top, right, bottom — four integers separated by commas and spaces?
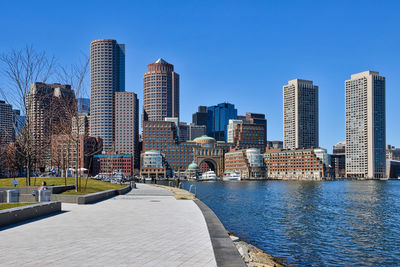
225, 148, 266, 179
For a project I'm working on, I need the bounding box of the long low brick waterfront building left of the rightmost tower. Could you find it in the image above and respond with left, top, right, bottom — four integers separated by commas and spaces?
264, 148, 329, 180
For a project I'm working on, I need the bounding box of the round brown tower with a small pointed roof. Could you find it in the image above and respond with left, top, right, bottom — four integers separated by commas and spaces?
143, 58, 179, 121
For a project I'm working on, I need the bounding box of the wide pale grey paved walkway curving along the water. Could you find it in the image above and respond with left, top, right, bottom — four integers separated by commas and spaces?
0, 184, 216, 266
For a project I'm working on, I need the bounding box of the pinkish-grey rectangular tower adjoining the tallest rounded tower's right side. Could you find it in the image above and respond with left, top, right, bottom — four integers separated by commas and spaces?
114, 92, 139, 168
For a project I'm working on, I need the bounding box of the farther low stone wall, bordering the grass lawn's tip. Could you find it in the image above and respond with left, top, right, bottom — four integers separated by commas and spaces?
51, 185, 131, 204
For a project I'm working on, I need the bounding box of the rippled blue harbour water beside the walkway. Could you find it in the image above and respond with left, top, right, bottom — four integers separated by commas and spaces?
185, 181, 400, 266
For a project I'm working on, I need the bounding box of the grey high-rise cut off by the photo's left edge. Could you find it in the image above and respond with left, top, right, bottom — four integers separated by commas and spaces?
0, 100, 15, 145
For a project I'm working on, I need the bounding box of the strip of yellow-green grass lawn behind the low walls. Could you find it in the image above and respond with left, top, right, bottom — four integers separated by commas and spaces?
0, 177, 126, 195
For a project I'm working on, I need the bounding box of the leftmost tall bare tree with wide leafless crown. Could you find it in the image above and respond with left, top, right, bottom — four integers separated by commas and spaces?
0, 46, 55, 186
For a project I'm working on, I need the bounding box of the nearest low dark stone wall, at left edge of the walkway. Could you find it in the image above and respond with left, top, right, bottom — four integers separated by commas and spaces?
0, 201, 61, 227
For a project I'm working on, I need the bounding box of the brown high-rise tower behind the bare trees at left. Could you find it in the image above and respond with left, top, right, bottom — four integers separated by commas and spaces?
27, 82, 76, 169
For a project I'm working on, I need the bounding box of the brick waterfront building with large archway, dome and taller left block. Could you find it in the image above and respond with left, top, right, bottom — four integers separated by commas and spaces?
142, 121, 230, 175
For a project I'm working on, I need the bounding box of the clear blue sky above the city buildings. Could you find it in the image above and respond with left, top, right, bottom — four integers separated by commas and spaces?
0, 0, 400, 151
